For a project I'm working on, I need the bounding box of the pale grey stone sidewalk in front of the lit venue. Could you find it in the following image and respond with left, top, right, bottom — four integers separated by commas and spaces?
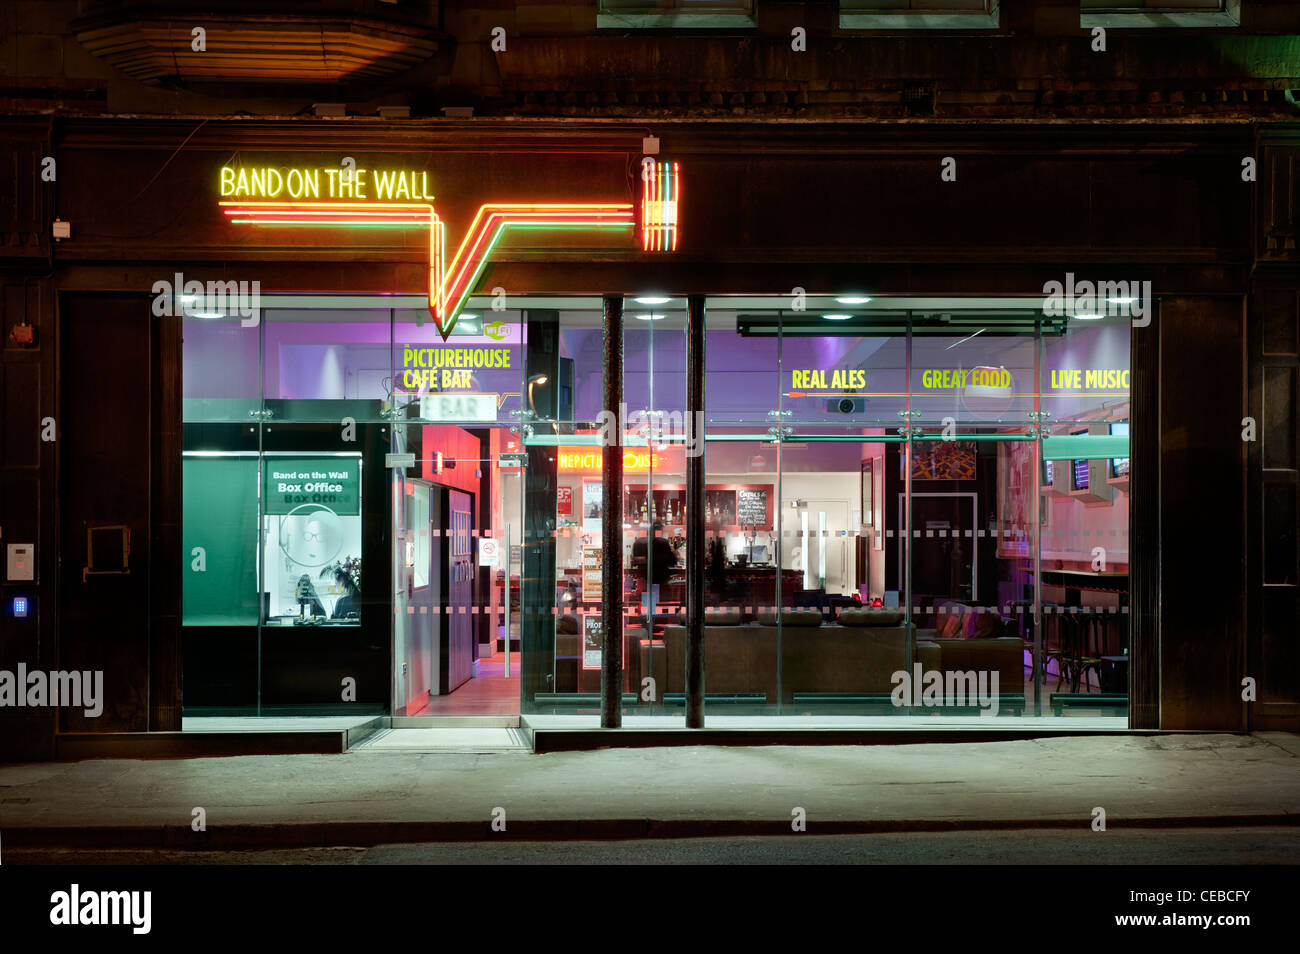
0, 733, 1300, 849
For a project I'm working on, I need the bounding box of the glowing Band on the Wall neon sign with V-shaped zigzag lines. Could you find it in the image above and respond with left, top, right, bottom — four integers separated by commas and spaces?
218, 159, 681, 339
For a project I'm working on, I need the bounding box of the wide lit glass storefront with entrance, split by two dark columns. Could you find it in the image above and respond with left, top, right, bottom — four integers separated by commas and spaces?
182, 296, 1130, 724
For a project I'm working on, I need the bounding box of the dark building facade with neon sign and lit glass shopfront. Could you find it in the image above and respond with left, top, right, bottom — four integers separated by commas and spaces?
0, 0, 1300, 759
